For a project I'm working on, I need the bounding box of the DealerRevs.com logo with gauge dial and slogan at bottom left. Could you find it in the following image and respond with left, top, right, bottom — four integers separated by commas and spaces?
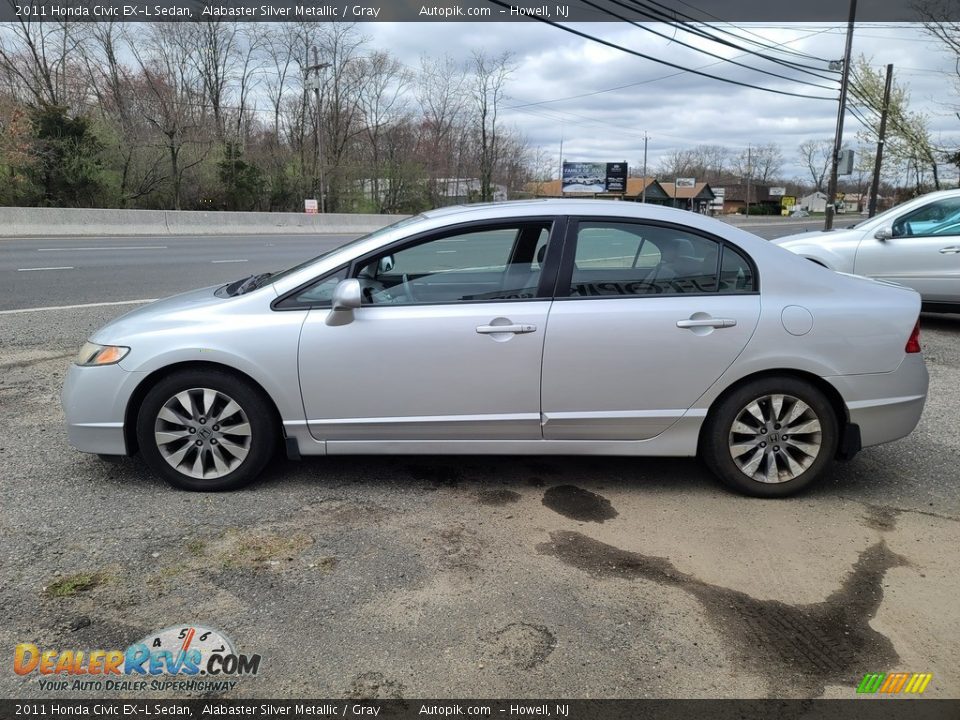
13, 625, 261, 692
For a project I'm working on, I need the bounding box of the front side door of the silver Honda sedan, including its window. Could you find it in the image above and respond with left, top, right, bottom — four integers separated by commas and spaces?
293, 219, 556, 442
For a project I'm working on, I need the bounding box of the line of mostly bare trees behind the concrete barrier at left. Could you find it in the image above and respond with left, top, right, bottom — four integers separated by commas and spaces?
0, 20, 530, 213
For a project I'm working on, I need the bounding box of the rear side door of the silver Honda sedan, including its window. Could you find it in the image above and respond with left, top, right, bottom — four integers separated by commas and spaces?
542, 219, 760, 440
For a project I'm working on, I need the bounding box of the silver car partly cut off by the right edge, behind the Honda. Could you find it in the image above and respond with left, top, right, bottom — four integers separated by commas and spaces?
773, 190, 960, 312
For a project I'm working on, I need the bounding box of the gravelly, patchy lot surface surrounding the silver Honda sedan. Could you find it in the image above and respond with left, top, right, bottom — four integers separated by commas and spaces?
0, 307, 960, 698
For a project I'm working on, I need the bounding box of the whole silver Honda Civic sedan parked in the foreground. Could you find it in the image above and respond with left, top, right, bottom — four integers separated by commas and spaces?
63, 200, 927, 497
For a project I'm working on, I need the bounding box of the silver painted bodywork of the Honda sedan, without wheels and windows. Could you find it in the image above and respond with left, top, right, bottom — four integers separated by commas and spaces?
63, 200, 927, 456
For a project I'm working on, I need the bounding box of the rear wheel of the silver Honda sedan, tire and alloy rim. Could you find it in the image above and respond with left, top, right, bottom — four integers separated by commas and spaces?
701, 377, 840, 498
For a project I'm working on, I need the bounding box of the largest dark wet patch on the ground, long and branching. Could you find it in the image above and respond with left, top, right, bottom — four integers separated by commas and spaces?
537, 531, 908, 697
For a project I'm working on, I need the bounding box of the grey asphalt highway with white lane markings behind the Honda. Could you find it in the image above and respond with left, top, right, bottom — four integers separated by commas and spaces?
0, 219, 836, 311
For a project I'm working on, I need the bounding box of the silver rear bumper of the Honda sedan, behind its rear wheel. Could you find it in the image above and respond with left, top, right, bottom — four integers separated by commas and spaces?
825, 353, 929, 447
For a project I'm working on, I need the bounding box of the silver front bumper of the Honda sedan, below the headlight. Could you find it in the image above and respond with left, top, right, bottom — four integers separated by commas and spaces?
60, 365, 145, 455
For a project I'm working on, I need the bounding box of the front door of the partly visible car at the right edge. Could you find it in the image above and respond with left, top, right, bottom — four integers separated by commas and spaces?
853, 197, 960, 303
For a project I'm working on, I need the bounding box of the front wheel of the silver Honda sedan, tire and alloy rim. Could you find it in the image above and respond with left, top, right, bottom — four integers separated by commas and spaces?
137, 370, 279, 492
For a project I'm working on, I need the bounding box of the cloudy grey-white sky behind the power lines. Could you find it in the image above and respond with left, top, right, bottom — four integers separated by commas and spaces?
362, 22, 960, 183
